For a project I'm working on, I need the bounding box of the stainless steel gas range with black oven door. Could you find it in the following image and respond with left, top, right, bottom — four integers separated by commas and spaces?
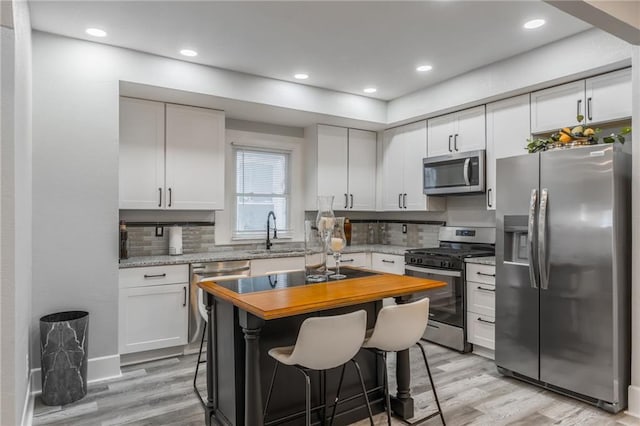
405, 226, 496, 352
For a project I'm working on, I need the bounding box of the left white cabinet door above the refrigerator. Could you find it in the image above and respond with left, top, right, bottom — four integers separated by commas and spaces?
531, 80, 586, 133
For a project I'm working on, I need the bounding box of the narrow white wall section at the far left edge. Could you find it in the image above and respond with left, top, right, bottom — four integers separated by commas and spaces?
0, 0, 32, 425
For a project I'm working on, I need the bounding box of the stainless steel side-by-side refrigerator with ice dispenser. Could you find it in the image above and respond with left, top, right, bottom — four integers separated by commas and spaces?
495, 145, 631, 412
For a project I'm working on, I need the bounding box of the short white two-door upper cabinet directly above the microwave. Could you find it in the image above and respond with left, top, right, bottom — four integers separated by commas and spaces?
427, 105, 485, 157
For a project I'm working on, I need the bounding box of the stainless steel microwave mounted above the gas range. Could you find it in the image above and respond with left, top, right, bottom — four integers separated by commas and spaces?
422, 149, 485, 195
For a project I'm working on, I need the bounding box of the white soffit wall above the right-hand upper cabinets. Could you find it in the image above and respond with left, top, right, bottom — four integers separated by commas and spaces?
387, 29, 631, 124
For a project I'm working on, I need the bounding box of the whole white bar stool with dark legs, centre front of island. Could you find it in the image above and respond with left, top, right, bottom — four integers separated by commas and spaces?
264, 310, 373, 426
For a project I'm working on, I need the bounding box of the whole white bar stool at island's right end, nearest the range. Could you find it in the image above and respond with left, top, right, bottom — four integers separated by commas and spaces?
362, 298, 446, 425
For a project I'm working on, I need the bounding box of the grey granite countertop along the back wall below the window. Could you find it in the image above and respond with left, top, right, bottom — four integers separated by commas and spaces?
120, 244, 413, 269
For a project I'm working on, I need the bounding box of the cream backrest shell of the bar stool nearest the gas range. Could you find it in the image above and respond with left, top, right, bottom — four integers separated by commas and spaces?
365, 298, 429, 352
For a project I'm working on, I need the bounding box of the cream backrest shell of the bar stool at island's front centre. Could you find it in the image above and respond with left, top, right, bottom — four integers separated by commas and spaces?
289, 310, 367, 370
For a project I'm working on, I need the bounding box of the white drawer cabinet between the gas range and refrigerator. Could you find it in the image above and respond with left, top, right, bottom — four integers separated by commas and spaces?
466, 263, 496, 359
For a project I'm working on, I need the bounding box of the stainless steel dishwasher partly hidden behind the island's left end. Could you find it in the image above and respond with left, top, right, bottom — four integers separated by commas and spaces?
189, 260, 251, 343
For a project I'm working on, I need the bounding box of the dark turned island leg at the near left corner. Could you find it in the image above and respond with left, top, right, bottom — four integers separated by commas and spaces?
240, 310, 264, 426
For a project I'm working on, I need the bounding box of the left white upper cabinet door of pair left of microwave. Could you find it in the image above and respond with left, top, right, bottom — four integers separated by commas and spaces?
381, 128, 404, 210
